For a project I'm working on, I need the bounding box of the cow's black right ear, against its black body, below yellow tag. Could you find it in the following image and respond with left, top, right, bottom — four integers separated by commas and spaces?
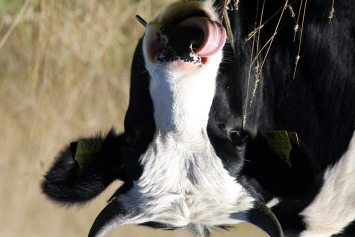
245, 135, 317, 198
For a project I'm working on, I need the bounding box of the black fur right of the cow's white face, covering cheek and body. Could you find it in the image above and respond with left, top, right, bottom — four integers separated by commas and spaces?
209, 0, 355, 236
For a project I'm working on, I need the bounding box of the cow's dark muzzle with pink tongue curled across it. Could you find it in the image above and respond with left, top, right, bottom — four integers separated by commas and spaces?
143, 4, 226, 64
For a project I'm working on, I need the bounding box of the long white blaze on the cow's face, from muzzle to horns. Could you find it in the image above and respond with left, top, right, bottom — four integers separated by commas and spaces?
114, 2, 255, 235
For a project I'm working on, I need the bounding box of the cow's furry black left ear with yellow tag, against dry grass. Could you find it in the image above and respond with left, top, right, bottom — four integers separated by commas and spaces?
41, 130, 126, 206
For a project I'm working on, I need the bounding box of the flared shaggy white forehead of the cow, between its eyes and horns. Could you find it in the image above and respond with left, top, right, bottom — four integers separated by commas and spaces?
119, 131, 254, 232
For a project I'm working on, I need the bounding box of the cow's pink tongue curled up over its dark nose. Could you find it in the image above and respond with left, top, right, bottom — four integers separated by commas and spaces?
179, 17, 227, 57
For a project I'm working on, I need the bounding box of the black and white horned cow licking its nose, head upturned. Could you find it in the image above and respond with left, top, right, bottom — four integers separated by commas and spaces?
42, 0, 355, 237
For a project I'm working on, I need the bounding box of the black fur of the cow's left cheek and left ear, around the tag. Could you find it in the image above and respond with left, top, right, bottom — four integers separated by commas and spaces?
41, 40, 155, 206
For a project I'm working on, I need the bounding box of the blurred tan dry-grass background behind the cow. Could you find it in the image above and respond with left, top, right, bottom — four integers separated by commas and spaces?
0, 0, 267, 237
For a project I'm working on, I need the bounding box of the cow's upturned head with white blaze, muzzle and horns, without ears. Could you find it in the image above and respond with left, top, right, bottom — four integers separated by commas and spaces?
90, 1, 282, 236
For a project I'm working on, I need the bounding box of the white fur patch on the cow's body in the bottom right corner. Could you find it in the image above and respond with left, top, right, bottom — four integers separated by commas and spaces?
301, 133, 355, 237
